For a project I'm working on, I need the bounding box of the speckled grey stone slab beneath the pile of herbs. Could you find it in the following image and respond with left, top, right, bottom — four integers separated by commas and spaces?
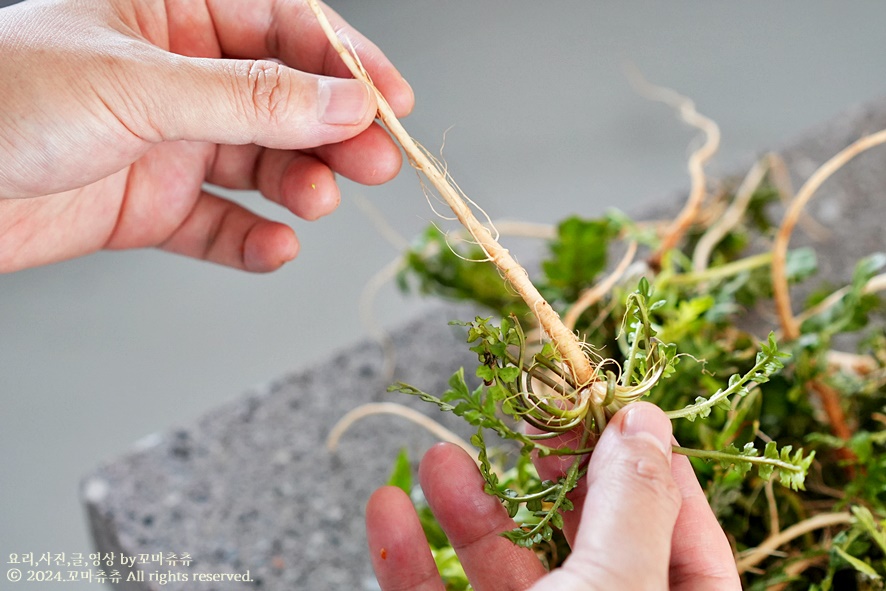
82, 101, 886, 591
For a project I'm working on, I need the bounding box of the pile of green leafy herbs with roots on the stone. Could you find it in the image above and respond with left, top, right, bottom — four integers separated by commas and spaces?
394, 169, 886, 590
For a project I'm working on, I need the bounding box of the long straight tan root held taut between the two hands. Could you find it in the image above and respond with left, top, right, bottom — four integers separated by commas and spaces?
308, 0, 594, 385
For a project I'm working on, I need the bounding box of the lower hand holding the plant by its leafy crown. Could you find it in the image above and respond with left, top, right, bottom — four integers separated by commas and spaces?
366, 402, 741, 591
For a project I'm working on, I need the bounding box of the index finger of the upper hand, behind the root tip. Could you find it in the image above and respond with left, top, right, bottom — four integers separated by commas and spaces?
207, 0, 414, 117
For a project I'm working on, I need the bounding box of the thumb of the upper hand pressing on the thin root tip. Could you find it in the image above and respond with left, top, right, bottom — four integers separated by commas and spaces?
149, 56, 376, 150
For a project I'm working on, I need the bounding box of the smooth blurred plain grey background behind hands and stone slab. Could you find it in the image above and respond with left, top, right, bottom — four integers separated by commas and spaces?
0, 0, 886, 587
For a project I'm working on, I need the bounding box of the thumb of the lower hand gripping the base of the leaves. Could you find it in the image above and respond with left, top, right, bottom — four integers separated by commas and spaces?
551, 402, 681, 589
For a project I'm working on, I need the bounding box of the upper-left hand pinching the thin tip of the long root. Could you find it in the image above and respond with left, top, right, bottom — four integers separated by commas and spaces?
0, 0, 413, 272
